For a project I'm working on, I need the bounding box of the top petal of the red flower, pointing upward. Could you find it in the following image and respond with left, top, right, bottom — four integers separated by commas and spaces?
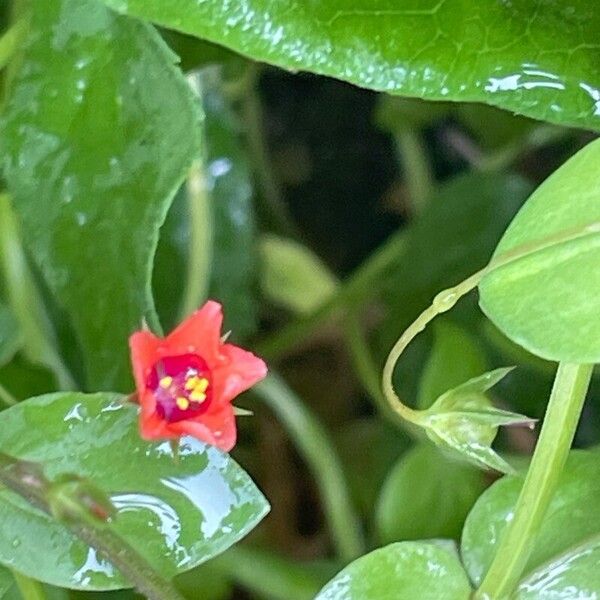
164, 300, 223, 366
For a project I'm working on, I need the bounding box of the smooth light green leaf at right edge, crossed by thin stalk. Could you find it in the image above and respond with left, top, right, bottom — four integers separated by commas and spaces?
480, 140, 600, 363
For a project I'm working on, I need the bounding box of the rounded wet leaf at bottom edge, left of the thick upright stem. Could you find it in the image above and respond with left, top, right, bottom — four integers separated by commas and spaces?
315, 542, 471, 600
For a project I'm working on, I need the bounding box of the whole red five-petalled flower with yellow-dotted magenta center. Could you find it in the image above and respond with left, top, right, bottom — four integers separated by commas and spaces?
129, 301, 267, 452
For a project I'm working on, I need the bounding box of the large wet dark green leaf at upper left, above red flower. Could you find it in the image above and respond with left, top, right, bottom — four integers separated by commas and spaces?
1, 0, 199, 390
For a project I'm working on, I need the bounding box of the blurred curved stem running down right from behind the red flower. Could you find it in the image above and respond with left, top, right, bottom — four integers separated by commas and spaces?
254, 374, 364, 562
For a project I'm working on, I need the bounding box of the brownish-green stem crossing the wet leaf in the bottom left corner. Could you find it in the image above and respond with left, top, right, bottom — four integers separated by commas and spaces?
0, 453, 182, 600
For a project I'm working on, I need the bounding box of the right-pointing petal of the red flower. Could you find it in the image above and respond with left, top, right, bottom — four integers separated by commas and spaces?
213, 344, 267, 403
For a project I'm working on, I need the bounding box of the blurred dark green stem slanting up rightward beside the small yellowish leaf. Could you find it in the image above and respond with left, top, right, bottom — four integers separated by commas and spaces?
255, 231, 407, 360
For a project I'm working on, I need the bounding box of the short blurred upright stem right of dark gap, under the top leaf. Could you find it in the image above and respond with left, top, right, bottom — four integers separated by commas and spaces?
394, 129, 434, 215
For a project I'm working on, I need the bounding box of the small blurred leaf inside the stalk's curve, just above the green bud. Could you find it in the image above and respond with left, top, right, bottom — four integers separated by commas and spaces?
417, 321, 487, 408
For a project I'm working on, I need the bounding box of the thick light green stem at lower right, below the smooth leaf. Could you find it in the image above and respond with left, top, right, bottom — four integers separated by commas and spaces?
474, 363, 593, 600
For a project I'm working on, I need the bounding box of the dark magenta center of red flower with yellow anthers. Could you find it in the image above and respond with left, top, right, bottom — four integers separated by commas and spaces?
146, 354, 212, 423
